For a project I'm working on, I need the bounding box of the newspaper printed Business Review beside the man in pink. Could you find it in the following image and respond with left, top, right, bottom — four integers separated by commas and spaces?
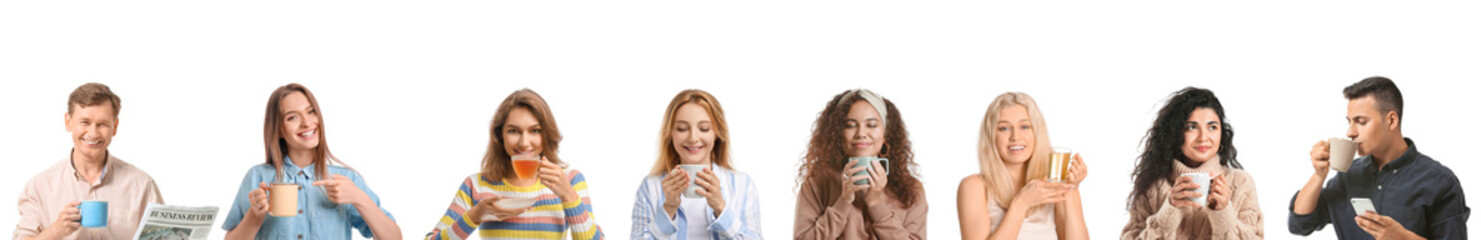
133, 203, 218, 240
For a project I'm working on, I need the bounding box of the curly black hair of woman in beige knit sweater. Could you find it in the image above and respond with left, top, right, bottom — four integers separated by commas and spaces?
1127, 87, 1244, 206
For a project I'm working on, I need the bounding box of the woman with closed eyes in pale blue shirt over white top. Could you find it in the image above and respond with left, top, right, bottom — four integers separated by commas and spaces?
632, 89, 761, 240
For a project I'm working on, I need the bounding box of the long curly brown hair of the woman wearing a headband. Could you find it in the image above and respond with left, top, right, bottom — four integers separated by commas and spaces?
797, 90, 921, 206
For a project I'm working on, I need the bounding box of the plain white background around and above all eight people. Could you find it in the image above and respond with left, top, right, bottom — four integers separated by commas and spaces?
0, 1, 1481, 239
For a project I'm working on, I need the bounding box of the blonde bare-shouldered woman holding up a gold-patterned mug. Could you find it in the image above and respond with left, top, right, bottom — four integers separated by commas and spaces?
957, 92, 1090, 240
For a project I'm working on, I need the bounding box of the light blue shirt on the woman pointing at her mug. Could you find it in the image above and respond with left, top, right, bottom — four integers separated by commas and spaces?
221, 157, 395, 240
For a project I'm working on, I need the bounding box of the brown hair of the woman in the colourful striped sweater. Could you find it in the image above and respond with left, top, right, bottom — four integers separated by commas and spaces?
480, 89, 566, 181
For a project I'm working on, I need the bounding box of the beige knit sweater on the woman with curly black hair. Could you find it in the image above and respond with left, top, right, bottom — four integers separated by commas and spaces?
1121, 159, 1265, 240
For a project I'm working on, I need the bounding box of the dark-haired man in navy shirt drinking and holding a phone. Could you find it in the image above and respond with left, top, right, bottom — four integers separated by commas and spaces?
1288, 77, 1471, 239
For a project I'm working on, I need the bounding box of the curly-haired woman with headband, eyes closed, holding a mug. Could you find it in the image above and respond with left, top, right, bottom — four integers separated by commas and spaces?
792, 89, 926, 240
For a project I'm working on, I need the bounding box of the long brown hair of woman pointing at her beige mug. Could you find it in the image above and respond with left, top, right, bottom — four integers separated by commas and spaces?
262, 83, 350, 181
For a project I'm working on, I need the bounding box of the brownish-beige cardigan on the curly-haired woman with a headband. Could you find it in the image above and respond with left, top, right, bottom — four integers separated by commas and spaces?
792, 182, 926, 240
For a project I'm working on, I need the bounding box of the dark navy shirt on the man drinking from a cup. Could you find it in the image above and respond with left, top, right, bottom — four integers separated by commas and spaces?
1288, 138, 1471, 239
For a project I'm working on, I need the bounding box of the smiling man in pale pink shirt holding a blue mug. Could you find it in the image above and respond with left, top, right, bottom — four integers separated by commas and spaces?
13, 83, 164, 240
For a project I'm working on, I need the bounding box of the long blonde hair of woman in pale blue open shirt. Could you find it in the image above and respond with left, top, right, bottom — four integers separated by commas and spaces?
649, 89, 733, 176
